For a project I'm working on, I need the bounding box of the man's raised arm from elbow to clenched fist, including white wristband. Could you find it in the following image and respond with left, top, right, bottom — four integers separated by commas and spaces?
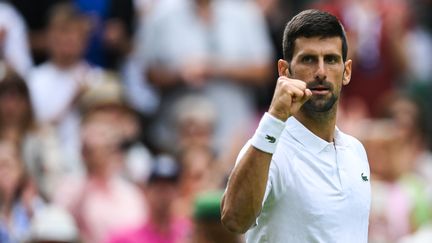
221, 66, 312, 233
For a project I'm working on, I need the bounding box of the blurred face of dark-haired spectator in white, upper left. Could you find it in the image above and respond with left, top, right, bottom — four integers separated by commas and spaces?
48, 17, 88, 66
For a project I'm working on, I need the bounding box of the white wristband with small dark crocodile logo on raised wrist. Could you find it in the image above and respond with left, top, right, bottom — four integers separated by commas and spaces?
251, 112, 285, 154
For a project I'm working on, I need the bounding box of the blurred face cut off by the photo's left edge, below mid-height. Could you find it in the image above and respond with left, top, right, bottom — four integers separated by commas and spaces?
0, 141, 23, 200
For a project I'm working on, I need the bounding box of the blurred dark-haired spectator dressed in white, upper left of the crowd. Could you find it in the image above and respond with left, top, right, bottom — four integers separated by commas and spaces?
28, 3, 111, 175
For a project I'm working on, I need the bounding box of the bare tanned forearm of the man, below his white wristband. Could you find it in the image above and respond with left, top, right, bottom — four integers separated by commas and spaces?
222, 145, 272, 233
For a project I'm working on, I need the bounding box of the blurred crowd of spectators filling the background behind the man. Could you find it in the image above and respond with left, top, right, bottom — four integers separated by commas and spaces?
0, 0, 432, 243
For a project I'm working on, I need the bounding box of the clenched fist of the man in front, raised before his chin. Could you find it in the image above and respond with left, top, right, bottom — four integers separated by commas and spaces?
269, 76, 312, 121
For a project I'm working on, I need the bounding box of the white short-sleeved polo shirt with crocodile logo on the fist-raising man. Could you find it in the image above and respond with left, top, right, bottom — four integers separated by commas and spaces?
239, 117, 371, 243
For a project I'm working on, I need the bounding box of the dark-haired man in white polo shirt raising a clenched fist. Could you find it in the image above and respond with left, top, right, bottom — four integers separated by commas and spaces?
222, 10, 370, 243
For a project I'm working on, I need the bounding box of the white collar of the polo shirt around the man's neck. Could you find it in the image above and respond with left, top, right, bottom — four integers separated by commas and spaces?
285, 116, 342, 154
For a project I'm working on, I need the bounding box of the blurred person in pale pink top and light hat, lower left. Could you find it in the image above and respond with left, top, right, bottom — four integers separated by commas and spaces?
55, 111, 147, 243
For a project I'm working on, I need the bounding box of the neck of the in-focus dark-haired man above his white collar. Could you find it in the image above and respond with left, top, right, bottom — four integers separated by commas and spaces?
294, 104, 337, 142
